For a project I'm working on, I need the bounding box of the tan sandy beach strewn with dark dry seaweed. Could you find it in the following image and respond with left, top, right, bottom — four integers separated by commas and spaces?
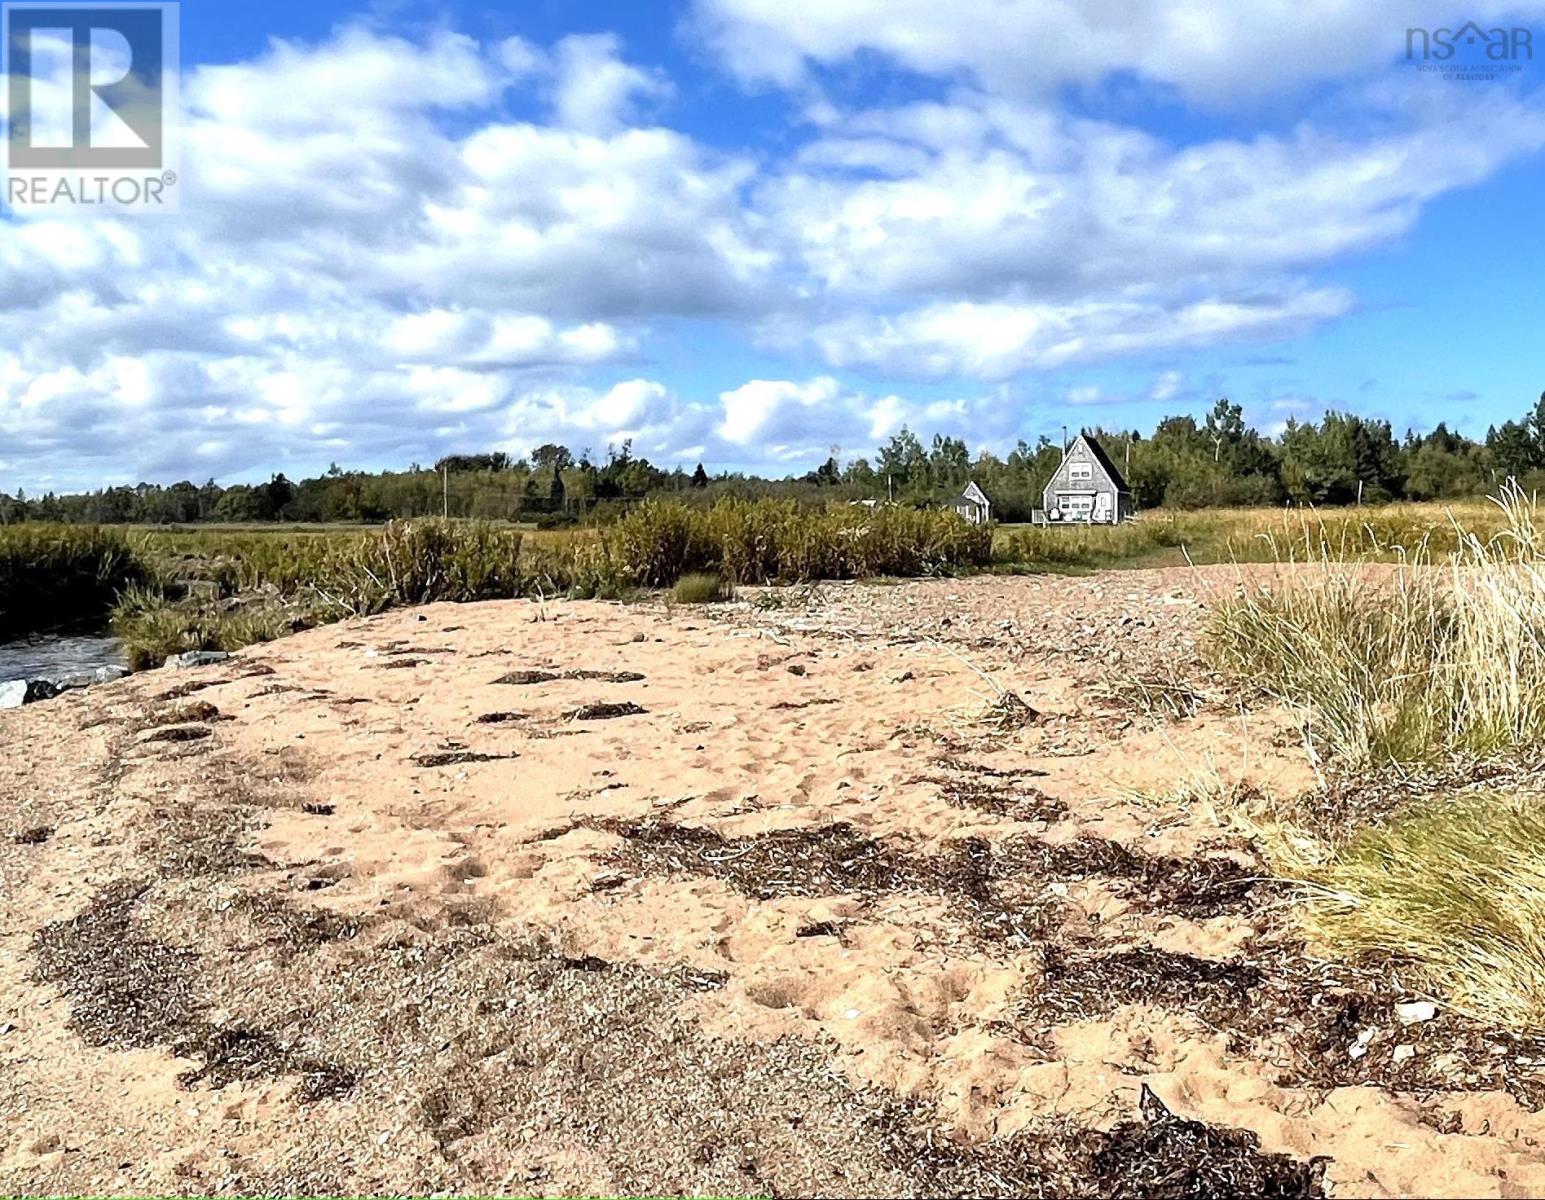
0, 568, 1545, 1197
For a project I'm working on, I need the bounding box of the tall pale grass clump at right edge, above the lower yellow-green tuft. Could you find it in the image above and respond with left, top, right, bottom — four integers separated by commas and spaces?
1210, 488, 1545, 766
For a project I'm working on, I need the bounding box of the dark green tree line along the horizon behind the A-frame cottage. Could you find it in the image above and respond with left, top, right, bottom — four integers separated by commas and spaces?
0, 394, 1545, 527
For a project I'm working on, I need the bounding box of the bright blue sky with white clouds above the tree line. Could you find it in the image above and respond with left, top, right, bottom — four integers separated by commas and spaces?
0, 0, 1545, 491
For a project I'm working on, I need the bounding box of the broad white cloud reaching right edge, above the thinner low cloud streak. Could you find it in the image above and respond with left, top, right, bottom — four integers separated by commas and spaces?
759, 86, 1545, 298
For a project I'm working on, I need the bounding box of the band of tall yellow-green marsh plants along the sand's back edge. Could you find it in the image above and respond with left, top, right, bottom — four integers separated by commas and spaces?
116, 500, 992, 664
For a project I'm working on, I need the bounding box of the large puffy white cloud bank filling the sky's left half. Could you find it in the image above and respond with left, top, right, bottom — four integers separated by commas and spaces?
0, 29, 771, 486
